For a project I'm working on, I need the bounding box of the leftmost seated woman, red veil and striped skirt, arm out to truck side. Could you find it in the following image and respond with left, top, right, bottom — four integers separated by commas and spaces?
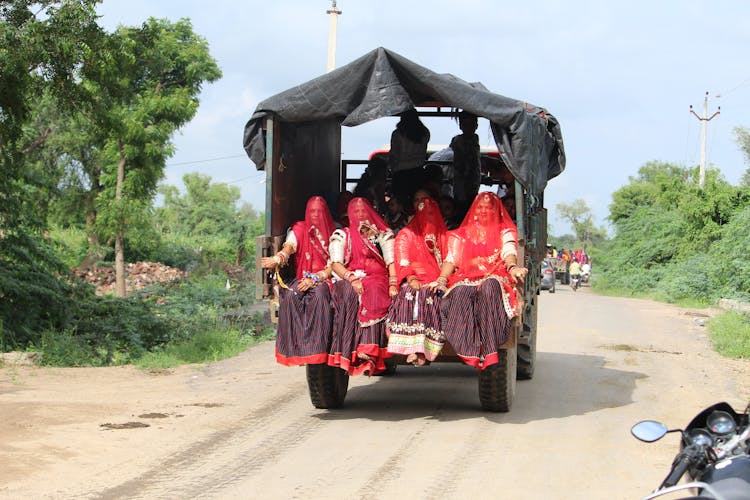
260, 196, 335, 366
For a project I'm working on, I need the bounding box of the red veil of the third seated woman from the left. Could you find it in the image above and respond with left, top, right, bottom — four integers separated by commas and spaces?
394, 198, 448, 285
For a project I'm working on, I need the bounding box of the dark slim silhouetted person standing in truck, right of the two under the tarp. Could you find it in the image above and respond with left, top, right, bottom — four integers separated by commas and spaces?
449, 111, 482, 215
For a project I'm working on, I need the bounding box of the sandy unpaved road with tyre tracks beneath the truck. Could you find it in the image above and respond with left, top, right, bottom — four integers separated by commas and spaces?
0, 286, 750, 499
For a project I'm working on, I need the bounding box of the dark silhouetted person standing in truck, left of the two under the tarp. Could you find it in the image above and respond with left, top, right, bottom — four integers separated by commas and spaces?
388, 108, 430, 207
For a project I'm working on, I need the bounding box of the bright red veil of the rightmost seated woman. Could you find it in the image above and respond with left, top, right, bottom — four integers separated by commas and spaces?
448, 192, 518, 284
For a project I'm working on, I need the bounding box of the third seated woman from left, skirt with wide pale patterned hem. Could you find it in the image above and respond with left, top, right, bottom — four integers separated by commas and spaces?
388, 198, 447, 366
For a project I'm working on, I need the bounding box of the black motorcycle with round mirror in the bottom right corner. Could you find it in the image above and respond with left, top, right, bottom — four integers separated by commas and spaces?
630, 402, 750, 500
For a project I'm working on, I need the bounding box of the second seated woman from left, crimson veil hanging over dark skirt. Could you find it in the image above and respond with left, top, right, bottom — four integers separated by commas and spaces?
328, 198, 398, 375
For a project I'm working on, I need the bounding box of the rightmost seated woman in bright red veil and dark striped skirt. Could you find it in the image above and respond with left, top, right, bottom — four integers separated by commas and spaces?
431, 192, 528, 370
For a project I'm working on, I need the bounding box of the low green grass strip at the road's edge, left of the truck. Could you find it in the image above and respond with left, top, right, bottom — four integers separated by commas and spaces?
133, 326, 273, 370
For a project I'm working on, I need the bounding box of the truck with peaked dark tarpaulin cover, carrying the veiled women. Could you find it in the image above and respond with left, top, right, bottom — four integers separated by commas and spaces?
243, 47, 565, 412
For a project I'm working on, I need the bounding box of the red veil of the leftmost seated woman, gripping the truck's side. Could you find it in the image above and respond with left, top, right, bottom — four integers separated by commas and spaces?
292, 196, 336, 280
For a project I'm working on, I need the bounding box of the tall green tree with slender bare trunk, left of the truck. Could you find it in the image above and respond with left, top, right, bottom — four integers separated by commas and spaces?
83, 18, 221, 296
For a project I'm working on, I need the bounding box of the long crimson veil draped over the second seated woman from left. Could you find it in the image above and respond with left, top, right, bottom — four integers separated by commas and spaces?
347, 197, 391, 326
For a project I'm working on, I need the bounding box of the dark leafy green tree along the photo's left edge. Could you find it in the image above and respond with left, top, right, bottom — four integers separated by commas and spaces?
0, 0, 102, 349
